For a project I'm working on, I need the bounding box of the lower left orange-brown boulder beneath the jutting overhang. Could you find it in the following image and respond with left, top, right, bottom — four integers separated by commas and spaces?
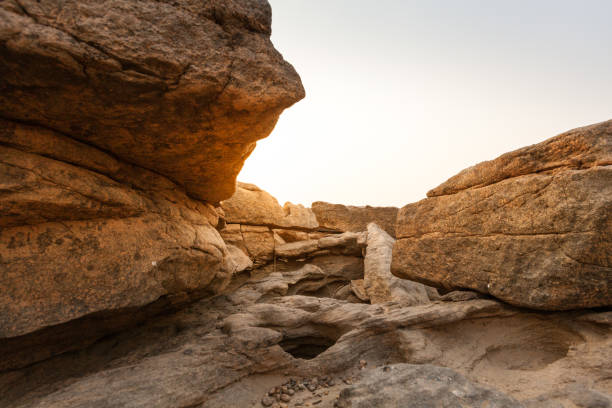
0, 131, 234, 338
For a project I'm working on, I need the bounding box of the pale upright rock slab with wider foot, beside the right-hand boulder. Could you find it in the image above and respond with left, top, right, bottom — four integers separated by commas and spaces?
363, 223, 430, 306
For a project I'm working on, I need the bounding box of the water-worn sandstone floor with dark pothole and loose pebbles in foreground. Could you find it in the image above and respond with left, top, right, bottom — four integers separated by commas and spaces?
0, 267, 612, 408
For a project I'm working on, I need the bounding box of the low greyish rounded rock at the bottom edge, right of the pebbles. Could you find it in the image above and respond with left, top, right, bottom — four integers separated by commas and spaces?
337, 364, 523, 408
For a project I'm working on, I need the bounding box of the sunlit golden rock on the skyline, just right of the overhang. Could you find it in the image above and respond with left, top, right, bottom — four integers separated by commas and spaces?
221, 183, 319, 229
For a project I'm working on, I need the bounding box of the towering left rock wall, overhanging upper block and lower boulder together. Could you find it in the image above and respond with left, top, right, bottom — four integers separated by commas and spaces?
0, 0, 304, 369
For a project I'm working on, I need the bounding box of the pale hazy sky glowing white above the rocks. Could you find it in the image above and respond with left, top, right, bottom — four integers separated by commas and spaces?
239, 0, 612, 207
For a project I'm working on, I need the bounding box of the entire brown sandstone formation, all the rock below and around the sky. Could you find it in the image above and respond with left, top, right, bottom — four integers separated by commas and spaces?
0, 0, 612, 408
